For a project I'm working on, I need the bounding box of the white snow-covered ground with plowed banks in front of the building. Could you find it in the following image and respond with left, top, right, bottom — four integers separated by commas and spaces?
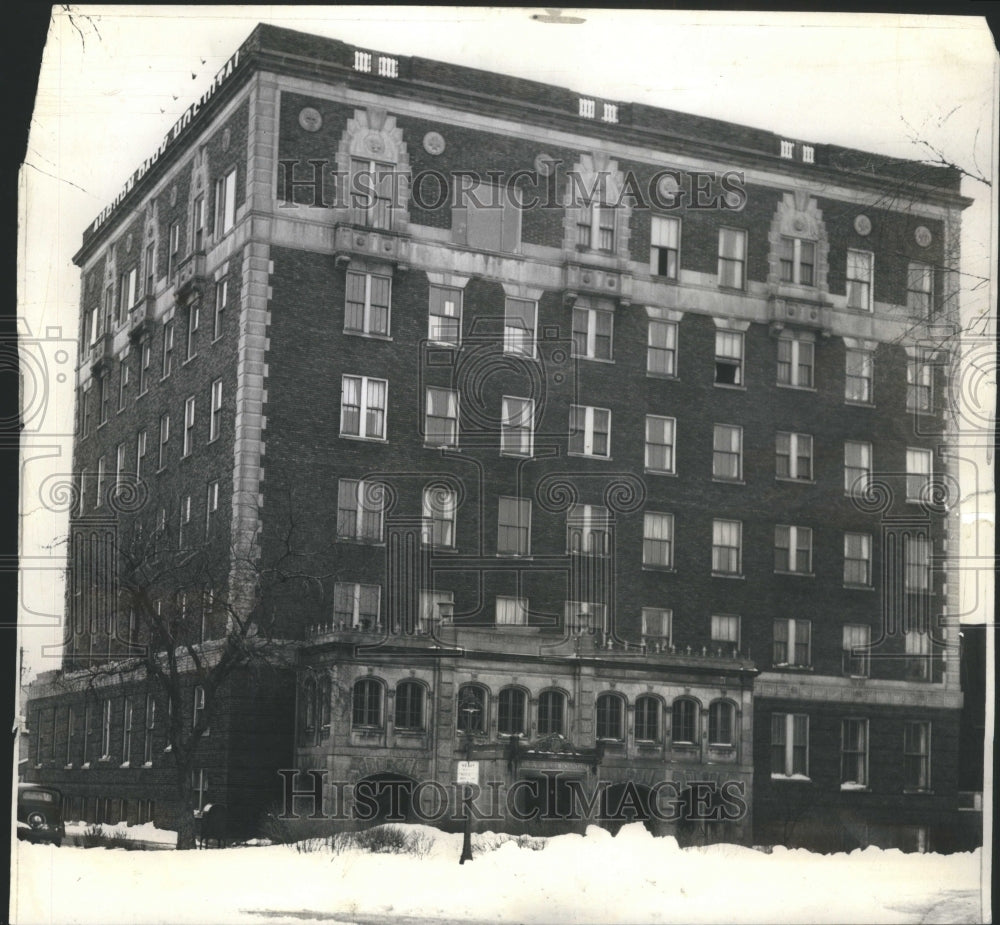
11, 825, 989, 925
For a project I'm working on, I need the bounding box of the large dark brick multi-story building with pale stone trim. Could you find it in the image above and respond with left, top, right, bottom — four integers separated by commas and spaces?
25, 19, 968, 848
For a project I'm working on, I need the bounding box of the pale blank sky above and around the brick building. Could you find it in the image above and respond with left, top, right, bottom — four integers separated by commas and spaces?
18, 5, 998, 671
